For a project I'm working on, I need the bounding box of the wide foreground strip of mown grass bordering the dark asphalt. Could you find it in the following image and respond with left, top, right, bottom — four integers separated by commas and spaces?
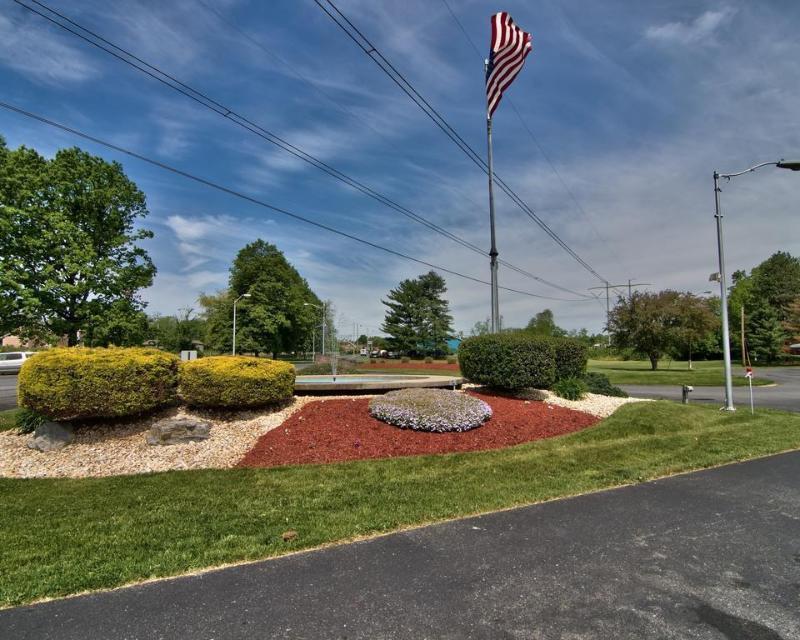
0, 402, 800, 606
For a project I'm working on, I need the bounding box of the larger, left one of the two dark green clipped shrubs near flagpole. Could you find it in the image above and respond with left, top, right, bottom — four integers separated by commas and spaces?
458, 332, 556, 390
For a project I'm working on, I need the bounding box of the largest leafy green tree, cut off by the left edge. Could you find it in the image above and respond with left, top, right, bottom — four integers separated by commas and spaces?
0, 138, 156, 345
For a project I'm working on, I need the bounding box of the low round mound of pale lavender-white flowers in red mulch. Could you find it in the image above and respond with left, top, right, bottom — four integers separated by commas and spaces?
369, 389, 492, 433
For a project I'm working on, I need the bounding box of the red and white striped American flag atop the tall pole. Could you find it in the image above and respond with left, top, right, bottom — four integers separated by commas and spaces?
486, 11, 533, 118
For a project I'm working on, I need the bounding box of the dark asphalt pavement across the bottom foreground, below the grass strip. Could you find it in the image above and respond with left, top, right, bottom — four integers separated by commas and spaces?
0, 452, 800, 640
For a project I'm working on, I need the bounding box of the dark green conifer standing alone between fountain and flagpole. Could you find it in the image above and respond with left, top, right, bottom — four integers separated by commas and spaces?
381, 271, 453, 355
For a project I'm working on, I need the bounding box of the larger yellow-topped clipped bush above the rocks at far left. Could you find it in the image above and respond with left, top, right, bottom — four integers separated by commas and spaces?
17, 347, 179, 420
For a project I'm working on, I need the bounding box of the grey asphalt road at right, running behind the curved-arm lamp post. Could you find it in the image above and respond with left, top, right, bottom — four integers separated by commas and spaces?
620, 367, 800, 412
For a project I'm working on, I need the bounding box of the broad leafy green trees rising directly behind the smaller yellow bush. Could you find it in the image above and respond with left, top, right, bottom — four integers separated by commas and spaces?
200, 239, 322, 355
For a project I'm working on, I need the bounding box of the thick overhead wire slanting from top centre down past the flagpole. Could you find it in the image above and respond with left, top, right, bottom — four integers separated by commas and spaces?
314, 0, 607, 282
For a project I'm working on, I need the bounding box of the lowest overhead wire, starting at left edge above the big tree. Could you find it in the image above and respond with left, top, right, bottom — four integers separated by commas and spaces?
0, 101, 585, 302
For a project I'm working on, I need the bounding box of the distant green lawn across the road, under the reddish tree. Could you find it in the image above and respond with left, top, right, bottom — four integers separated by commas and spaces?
589, 360, 772, 387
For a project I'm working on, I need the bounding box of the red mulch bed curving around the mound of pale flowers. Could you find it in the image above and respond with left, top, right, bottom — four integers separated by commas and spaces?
238, 393, 599, 467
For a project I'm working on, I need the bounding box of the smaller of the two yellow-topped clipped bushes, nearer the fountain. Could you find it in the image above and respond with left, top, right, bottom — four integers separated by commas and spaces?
179, 356, 295, 407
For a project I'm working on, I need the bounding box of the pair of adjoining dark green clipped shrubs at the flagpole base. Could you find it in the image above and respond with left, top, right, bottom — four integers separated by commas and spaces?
458, 331, 587, 390
